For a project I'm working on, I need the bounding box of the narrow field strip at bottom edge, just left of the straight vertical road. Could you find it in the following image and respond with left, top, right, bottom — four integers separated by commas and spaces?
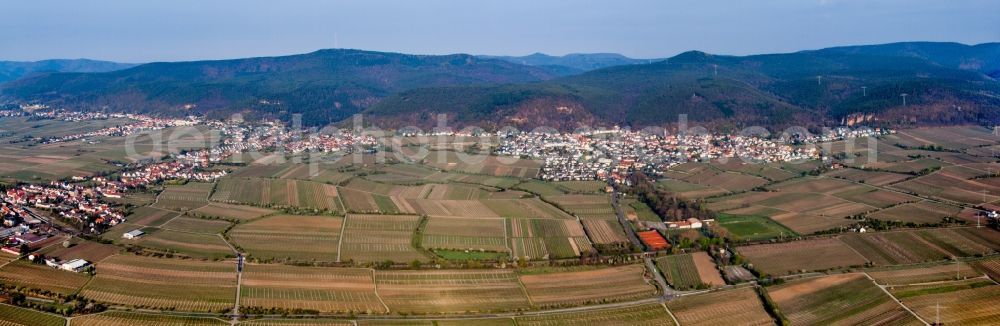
69, 311, 229, 326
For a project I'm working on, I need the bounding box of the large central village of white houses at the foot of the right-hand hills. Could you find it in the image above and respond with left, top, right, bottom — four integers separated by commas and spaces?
496, 128, 819, 182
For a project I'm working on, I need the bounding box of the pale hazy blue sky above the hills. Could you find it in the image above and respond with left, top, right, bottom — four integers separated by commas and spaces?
0, 0, 1000, 62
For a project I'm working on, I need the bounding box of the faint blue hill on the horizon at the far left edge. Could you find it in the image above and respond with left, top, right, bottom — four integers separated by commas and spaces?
0, 59, 135, 84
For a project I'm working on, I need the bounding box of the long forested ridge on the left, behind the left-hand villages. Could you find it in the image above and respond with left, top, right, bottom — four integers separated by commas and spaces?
0, 49, 553, 124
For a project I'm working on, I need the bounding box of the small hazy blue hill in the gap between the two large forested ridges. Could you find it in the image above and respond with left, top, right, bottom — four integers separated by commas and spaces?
479, 53, 662, 76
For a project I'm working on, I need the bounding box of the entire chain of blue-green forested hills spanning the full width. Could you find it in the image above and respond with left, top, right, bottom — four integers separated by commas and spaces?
0, 42, 1000, 129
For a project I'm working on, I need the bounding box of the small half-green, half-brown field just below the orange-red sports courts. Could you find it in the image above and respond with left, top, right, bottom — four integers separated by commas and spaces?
656, 251, 726, 290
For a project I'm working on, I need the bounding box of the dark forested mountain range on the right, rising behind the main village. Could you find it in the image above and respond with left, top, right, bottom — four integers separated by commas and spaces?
365, 43, 1000, 129
